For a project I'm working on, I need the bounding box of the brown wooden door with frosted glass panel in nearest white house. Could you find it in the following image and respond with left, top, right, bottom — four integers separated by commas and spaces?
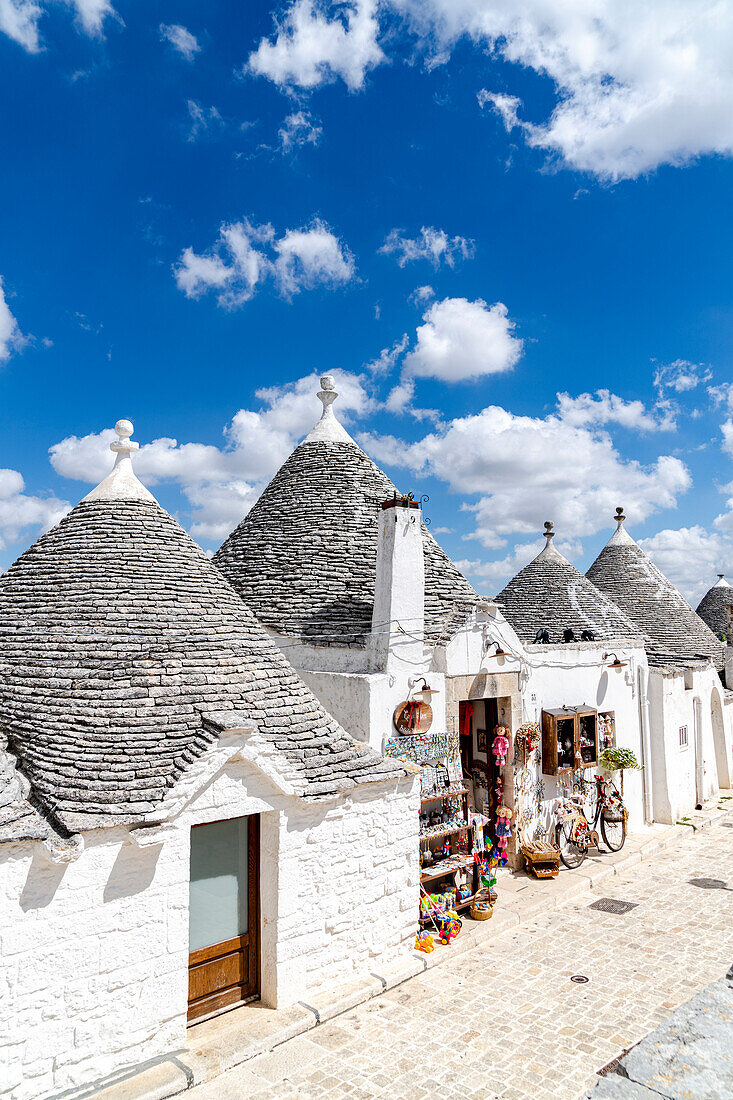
188, 815, 260, 1023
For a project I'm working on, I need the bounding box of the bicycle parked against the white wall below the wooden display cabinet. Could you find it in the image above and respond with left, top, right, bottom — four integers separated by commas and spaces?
555, 776, 628, 869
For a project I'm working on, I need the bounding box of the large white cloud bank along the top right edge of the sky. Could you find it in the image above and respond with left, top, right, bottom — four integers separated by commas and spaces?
249, 0, 733, 180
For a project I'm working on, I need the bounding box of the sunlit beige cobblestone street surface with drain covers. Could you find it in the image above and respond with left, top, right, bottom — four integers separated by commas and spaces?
187, 818, 733, 1100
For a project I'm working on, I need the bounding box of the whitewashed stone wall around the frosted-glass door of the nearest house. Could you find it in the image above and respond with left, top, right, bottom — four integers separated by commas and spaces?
0, 760, 419, 1100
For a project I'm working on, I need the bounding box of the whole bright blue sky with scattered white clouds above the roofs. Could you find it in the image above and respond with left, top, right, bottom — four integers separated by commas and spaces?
0, 0, 733, 600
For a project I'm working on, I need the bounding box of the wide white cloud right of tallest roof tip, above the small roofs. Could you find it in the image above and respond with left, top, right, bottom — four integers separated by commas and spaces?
360, 406, 691, 549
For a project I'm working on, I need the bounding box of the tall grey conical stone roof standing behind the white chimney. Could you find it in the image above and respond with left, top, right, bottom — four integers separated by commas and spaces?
214, 376, 478, 646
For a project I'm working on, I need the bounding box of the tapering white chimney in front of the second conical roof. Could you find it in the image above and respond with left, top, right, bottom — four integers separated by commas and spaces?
370, 494, 425, 675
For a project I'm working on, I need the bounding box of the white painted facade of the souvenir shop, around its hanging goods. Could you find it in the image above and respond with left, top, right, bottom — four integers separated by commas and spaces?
273, 589, 654, 850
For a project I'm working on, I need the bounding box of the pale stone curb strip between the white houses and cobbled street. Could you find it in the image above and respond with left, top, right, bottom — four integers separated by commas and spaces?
86, 806, 733, 1100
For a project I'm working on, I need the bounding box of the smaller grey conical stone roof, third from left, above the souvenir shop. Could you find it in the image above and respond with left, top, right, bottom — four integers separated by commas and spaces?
496, 523, 639, 644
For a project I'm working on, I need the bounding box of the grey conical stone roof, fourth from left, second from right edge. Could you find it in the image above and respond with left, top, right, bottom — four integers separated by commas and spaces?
587, 508, 723, 669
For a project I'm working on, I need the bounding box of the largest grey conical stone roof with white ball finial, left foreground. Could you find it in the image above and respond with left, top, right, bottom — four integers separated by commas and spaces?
0, 415, 401, 831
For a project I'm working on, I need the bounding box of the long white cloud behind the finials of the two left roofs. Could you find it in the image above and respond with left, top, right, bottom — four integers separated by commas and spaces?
50, 370, 376, 541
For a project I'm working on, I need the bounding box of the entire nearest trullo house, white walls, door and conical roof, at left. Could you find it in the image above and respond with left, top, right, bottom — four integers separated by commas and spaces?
0, 420, 418, 1100
